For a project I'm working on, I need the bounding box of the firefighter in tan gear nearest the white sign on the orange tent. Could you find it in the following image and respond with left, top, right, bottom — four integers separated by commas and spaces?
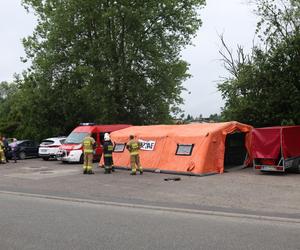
126, 135, 143, 175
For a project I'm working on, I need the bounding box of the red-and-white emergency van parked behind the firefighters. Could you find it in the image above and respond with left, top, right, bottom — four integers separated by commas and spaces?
57, 123, 131, 162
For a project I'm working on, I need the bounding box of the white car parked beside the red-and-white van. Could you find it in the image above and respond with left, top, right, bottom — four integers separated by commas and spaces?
39, 136, 66, 161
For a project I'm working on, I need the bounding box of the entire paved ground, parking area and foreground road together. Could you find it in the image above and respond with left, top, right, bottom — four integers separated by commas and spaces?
0, 159, 300, 250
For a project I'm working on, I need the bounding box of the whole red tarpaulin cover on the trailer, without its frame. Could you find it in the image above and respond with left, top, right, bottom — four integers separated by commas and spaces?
251, 126, 300, 159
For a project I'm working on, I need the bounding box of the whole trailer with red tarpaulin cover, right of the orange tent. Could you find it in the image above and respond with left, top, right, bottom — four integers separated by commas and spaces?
251, 126, 300, 172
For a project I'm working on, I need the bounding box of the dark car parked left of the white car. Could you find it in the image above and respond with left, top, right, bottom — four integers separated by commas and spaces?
8, 140, 39, 160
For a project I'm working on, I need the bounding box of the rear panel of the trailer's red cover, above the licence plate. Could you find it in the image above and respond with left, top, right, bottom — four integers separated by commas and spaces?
252, 127, 281, 159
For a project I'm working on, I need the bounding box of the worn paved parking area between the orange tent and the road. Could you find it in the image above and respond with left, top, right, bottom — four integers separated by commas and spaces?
0, 159, 300, 218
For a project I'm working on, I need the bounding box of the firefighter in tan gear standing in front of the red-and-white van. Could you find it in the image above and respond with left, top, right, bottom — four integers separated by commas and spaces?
83, 134, 96, 174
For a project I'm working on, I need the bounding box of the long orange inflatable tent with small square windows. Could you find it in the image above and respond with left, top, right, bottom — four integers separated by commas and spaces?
111, 122, 252, 174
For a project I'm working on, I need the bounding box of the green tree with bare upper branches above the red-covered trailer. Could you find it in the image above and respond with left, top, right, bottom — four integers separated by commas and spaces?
218, 0, 300, 126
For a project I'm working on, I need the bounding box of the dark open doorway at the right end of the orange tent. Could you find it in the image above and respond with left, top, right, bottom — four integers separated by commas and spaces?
224, 132, 247, 169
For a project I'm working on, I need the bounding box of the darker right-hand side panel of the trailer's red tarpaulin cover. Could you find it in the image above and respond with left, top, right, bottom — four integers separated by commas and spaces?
282, 126, 300, 159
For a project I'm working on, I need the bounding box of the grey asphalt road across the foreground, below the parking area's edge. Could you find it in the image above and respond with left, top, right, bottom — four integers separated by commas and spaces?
0, 194, 300, 250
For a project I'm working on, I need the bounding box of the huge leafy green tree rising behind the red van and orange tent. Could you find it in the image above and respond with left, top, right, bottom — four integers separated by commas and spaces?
14, 0, 204, 141
